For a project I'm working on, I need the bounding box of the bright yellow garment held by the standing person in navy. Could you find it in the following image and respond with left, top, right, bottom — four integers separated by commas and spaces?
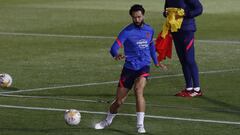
161, 8, 185, 38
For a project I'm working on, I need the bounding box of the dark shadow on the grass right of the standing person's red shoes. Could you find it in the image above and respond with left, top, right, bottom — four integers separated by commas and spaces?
201, 96, 240, 116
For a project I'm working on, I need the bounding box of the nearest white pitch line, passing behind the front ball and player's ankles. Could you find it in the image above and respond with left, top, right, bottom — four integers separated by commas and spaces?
0, 105, 240, 125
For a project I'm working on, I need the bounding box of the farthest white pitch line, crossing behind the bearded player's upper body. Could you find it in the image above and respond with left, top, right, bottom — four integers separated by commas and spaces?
0, 32, 240, 44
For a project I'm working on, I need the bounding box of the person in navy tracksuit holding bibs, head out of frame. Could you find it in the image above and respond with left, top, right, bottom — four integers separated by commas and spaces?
163, 0, 203, 97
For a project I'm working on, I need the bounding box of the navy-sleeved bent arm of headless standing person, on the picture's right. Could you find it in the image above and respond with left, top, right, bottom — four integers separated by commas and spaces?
184, 0, 203, 18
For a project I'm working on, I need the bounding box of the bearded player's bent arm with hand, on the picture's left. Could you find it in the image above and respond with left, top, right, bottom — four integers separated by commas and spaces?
110, 30, 127, 60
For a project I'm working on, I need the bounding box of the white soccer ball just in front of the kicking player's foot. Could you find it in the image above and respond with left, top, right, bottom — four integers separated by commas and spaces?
64, 109, 81, 126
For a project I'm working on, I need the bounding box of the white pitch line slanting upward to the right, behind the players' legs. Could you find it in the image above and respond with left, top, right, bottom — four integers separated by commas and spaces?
0, 69, 240, 94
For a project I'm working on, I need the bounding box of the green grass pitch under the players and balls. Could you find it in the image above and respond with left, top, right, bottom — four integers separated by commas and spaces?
0, 0, 240, 135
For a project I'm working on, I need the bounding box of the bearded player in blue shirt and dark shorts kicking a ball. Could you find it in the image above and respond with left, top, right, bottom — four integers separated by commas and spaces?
95, 4, 159, 133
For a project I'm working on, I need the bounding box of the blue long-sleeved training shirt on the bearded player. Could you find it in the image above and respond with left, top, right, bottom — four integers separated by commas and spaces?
110, 23, 158, 70
